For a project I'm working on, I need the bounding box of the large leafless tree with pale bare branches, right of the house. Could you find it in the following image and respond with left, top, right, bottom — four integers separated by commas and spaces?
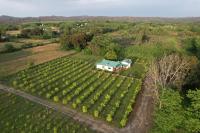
149, 54, 197, 88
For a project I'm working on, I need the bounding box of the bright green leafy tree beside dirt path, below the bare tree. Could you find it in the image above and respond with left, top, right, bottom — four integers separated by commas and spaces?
152, 88, 184, 133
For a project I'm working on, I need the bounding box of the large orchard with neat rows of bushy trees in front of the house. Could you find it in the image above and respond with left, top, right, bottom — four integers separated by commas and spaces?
10, 57, 141, 127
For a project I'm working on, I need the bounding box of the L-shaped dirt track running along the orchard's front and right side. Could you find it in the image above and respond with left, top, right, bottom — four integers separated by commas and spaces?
0, 77, 153, 133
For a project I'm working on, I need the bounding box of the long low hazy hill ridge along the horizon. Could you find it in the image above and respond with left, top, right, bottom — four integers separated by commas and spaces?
0, 15, 200, 23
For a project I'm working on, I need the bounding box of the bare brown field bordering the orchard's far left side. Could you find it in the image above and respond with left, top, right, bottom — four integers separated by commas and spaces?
0, 43, 75, 77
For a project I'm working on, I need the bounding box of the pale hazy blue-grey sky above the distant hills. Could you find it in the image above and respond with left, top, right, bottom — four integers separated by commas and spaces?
0, 0, 200, 17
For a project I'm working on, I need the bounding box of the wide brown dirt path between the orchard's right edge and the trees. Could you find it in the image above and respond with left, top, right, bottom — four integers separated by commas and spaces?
122, 78, 154, 133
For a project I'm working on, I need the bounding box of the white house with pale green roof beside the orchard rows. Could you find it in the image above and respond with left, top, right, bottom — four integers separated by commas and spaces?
96, 59, 132, 72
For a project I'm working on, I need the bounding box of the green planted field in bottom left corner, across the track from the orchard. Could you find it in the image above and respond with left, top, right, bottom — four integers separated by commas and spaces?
0, 91, 96, 133
